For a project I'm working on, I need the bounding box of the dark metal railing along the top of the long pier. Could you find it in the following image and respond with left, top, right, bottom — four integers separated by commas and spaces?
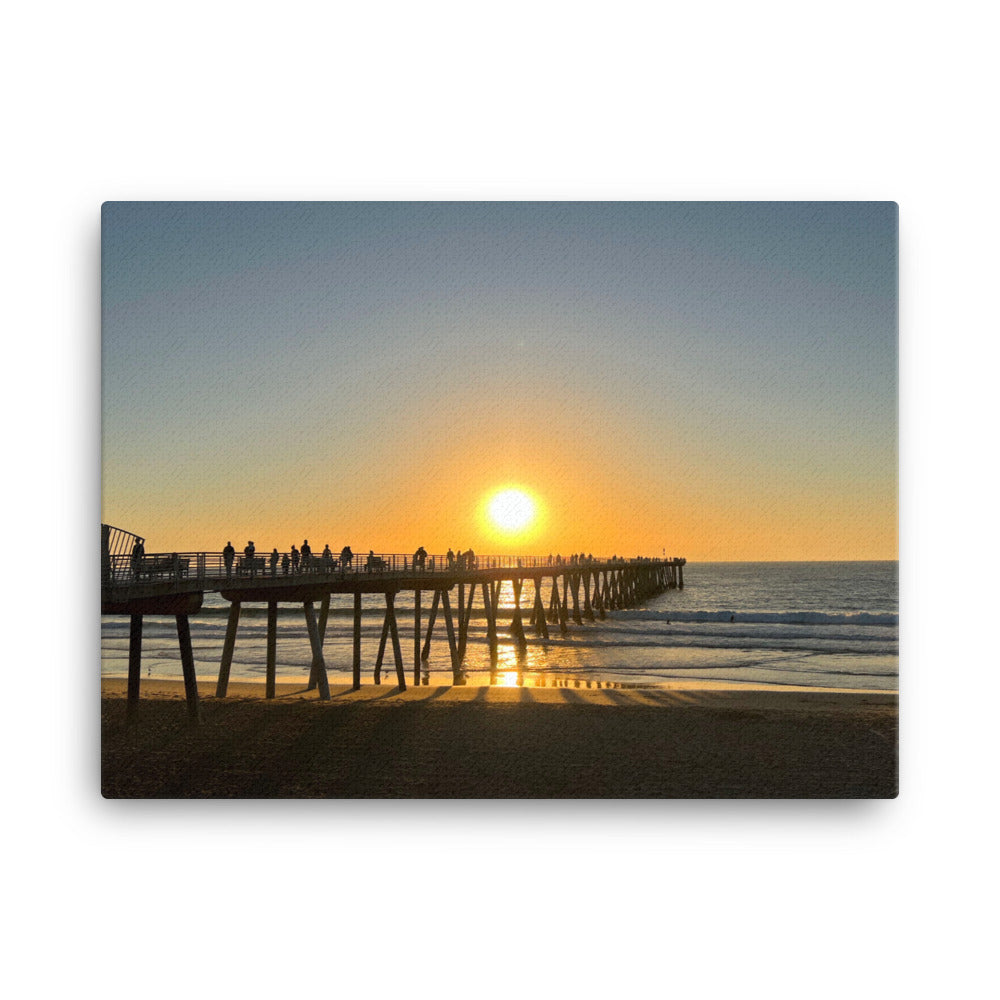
102, 551, 672, 586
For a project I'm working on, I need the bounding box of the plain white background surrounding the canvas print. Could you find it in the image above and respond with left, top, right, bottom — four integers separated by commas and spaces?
0, 0, 998, 997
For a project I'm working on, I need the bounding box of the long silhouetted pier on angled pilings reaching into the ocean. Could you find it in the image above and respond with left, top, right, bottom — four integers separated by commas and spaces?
101, 524, 686, 724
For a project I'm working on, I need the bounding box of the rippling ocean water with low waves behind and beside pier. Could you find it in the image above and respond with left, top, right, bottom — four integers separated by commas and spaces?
101, 561, 899, 691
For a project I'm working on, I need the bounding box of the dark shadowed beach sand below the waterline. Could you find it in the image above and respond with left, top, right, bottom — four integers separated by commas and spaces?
101, 679, 898, 799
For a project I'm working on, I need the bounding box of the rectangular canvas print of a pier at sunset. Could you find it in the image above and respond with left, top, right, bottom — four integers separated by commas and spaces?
100, 201, 899, 799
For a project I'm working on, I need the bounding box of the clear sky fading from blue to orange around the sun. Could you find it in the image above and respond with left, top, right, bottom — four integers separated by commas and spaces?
101, 202, 898, 561
